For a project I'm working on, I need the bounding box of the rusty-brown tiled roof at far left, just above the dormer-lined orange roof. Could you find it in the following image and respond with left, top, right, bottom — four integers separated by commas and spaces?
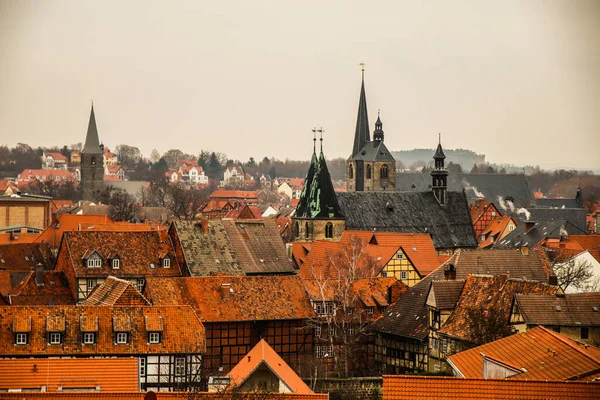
8, 271, 75, 306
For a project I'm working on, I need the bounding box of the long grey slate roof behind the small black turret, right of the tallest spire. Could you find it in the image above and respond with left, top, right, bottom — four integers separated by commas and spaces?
396, 173, 533, 207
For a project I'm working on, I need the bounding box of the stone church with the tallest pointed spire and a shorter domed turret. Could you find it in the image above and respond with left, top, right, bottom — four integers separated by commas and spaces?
346, 66, 396, 192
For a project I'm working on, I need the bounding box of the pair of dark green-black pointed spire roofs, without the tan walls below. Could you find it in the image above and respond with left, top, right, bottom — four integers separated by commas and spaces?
294, 145, 344, 219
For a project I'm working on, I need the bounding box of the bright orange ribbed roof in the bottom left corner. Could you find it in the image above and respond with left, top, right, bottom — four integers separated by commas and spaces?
0, 358, 138, 392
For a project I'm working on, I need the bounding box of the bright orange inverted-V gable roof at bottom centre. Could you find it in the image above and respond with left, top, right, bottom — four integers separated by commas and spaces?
227, 339, 313, 394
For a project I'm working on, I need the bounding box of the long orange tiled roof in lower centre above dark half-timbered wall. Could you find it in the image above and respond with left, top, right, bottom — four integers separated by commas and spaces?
146, 276, 314, 322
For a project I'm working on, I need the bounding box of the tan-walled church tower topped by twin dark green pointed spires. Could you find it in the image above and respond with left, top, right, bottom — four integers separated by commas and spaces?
292, 130, 346, 242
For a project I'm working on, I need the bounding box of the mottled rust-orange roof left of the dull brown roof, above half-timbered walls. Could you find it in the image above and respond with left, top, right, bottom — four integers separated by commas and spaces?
438, 275, 557, 342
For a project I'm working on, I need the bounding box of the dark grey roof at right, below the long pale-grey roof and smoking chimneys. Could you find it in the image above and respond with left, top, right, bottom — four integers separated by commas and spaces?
494, 220, 585, 249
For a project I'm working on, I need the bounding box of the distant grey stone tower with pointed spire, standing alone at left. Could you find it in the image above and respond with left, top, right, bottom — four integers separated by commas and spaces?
80, 104, 104, 202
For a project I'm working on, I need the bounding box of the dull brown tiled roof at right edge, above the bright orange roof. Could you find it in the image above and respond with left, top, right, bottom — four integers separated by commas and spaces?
515, 292, 600, 326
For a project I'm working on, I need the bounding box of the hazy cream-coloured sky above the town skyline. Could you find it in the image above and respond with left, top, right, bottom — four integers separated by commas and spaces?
0, 0, 600, 168
